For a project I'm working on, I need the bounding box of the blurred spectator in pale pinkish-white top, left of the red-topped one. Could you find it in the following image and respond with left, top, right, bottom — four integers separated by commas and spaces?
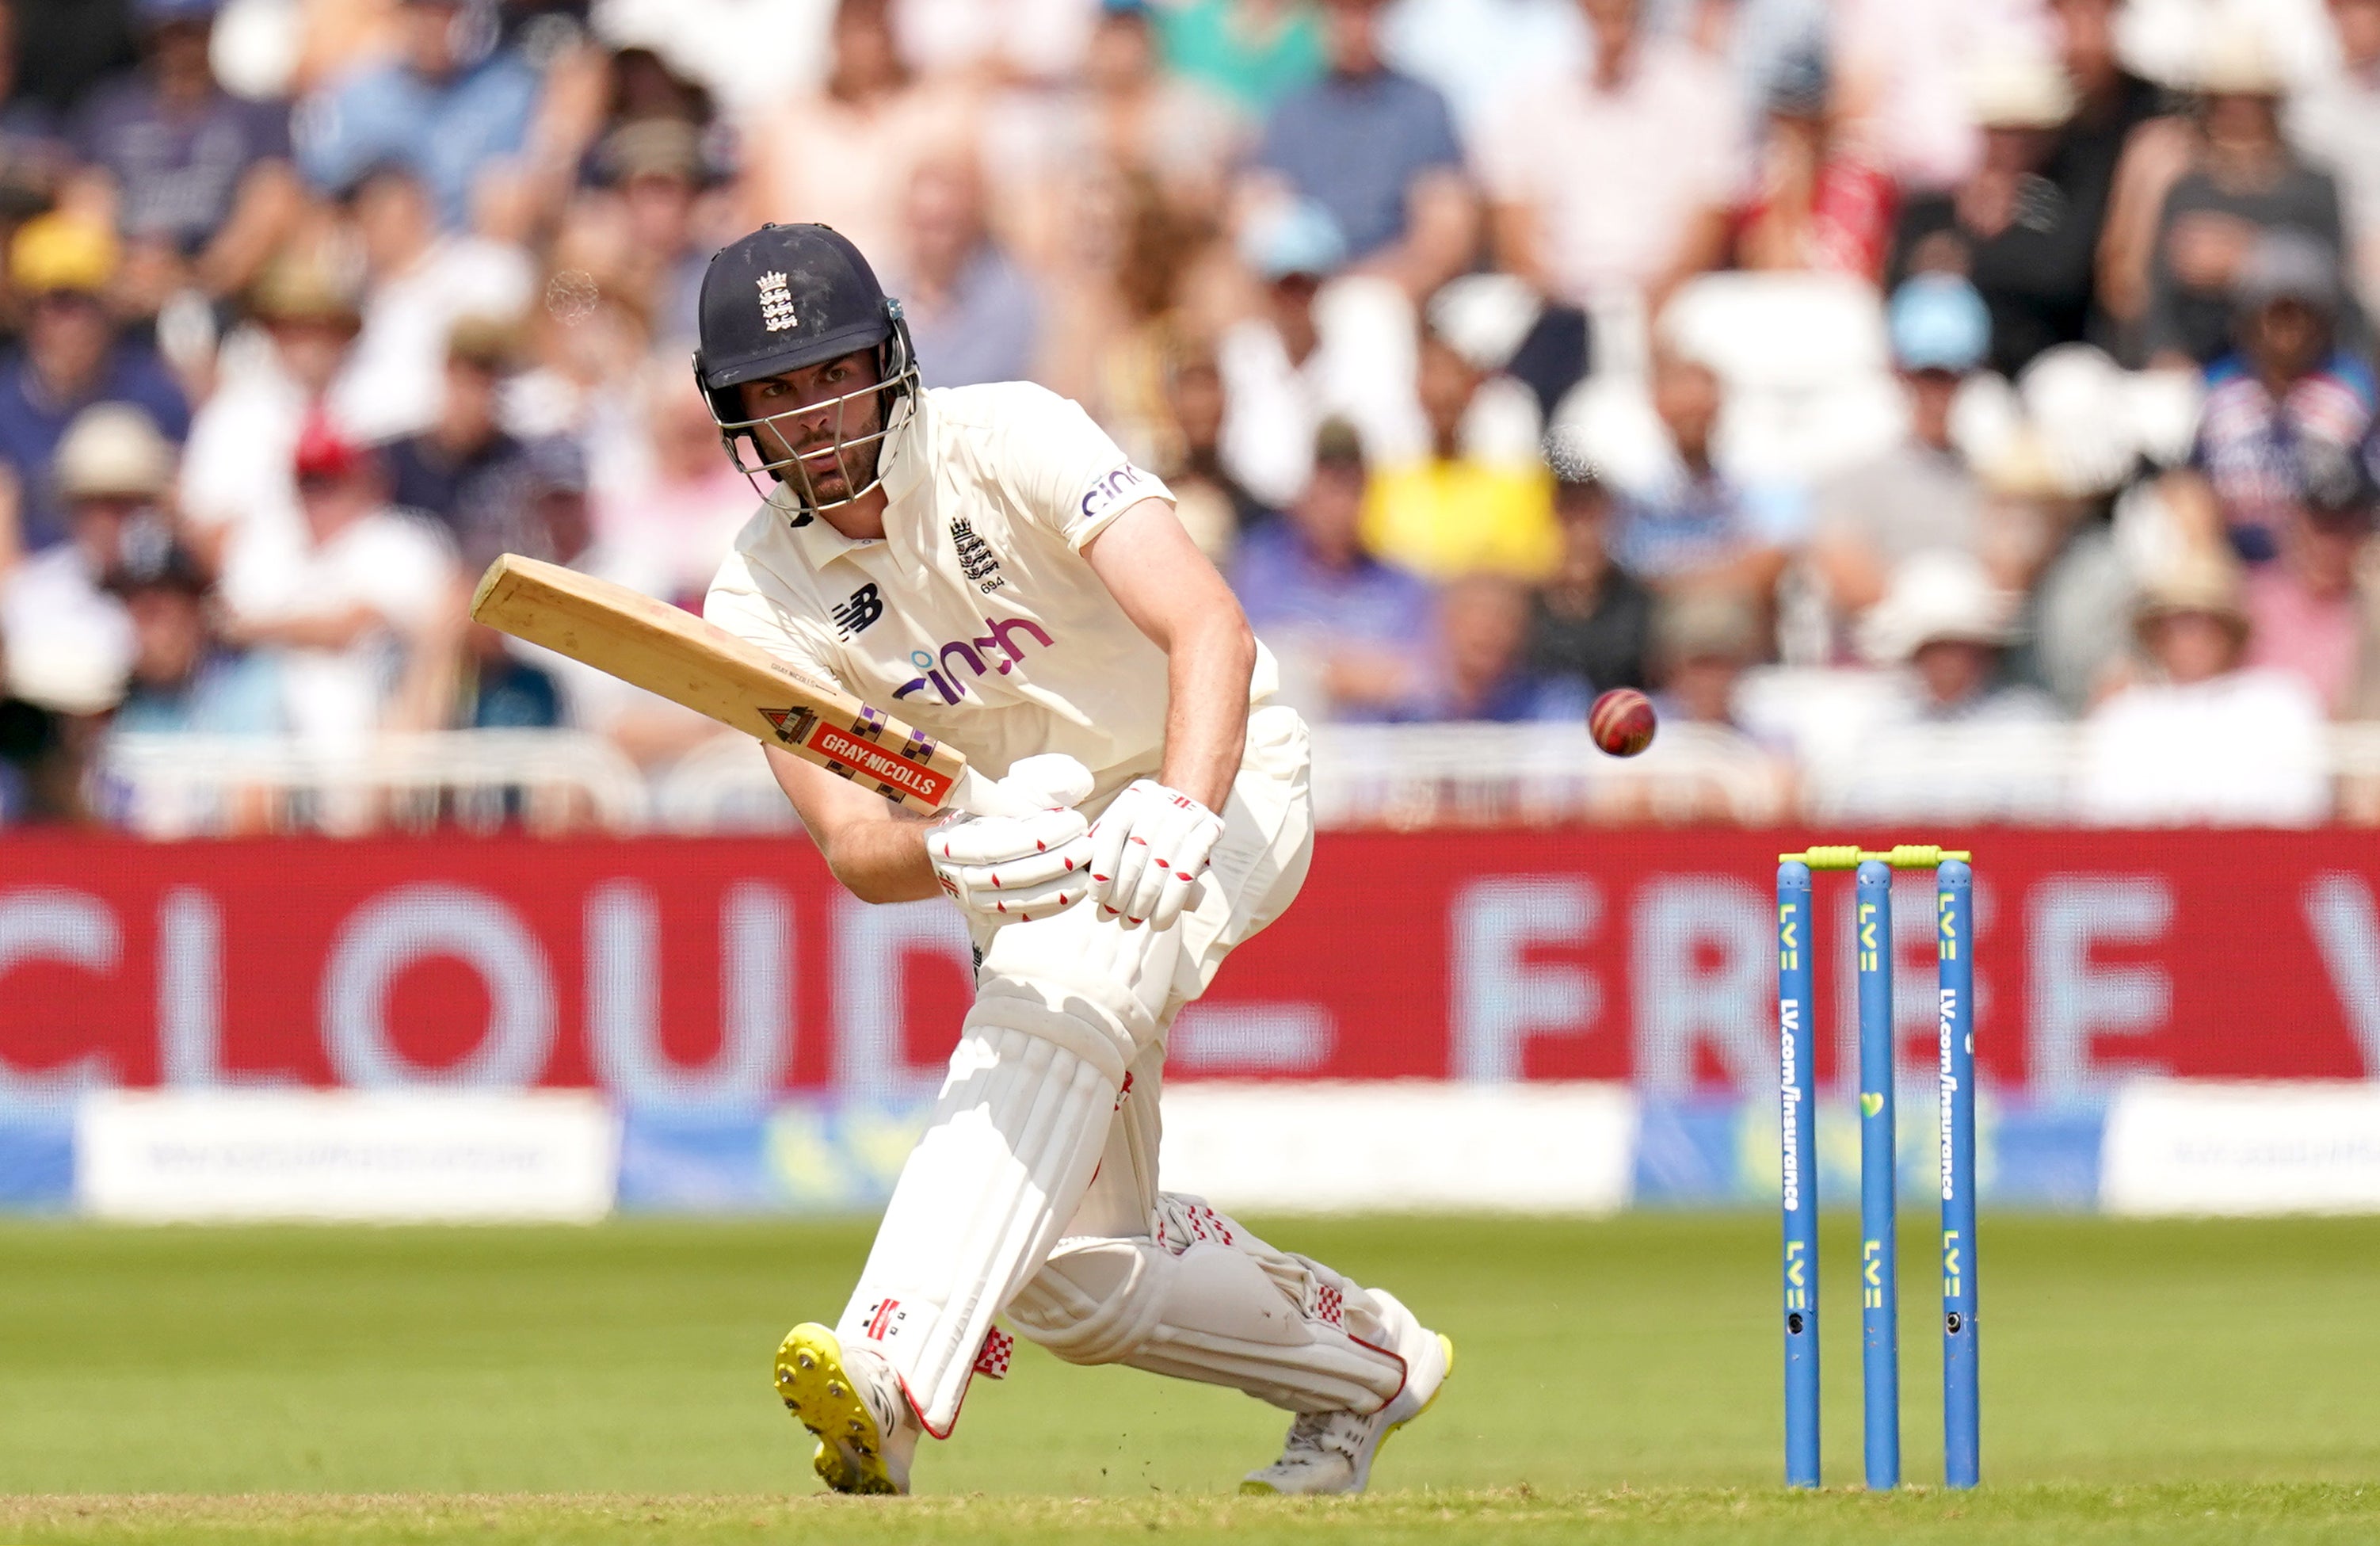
1475, 0, 1740, 307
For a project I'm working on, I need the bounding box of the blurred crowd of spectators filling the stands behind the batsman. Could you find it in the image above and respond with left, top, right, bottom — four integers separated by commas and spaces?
0, 0, 2380, 826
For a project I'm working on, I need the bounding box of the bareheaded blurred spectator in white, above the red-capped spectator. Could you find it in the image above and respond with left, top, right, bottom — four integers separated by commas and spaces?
341, 162, 536, 441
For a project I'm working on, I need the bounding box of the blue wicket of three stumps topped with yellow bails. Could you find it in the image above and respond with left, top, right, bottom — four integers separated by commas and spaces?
1778, 843, 1982, 1489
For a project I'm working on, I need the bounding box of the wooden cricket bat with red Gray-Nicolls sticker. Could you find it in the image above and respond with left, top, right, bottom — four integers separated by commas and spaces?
471, 552, 1033, 815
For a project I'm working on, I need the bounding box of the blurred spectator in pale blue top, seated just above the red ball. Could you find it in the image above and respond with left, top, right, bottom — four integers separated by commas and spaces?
1611, 345, 1806, 608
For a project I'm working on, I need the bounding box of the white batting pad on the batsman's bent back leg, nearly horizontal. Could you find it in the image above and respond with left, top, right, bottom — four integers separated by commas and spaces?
1009, 1193, 1418, 1413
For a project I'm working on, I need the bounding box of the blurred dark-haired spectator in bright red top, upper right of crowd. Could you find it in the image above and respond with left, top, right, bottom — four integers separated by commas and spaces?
1699, 45, 1894, 281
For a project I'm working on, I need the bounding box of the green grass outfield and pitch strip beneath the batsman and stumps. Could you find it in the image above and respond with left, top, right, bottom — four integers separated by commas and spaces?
0, 1215, 2380, 1546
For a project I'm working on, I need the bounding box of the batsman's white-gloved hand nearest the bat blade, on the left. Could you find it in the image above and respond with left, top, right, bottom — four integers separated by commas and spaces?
926, 755, 1090, 924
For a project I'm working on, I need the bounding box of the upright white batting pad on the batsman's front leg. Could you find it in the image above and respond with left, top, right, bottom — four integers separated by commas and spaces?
835, 1010, 1123, 1439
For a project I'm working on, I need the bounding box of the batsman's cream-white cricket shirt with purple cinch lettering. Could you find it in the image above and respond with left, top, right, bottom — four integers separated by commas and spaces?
702, 381, 1278, 793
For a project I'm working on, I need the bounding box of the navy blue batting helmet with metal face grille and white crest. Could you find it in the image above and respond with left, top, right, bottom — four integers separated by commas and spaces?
695, 224, 919, 512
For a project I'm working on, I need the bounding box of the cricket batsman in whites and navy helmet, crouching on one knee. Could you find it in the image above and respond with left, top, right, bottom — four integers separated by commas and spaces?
695, 227, 1454, 1494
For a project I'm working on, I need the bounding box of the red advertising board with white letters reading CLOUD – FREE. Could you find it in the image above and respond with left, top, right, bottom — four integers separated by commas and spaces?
0, 831, 2380, 1103
